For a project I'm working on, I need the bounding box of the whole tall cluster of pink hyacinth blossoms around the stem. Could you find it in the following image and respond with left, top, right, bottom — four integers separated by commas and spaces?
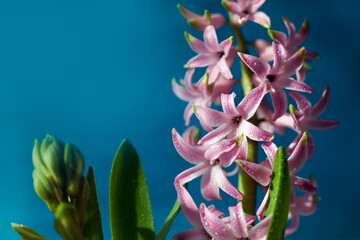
172, 0, 338, 240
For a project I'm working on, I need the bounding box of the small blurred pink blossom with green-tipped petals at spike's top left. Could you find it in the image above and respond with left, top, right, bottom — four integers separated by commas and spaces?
177, 4, 226, 31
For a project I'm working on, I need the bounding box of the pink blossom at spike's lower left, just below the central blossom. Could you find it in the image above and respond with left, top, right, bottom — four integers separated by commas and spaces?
172, 129, 243, 200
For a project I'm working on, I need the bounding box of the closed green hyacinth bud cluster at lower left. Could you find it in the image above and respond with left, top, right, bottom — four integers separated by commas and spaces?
32, 135, 89, 239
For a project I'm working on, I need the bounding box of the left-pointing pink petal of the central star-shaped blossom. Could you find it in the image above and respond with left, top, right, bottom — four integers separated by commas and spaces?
193, 105, 228, 127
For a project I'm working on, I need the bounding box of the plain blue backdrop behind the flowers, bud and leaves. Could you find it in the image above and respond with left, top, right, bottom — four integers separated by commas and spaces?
0, 0, 360, 239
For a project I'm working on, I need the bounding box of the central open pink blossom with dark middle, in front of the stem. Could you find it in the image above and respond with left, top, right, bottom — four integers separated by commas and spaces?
194, 84, 274, 166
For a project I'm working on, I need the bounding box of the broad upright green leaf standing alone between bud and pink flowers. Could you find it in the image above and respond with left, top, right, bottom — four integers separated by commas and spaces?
109, 139, 155, 240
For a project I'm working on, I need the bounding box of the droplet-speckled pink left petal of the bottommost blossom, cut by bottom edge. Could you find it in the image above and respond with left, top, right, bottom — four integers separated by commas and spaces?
200, 203, 234, 240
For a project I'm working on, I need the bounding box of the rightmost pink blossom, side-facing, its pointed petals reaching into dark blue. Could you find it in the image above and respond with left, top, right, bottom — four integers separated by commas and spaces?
287, 85, 339, 158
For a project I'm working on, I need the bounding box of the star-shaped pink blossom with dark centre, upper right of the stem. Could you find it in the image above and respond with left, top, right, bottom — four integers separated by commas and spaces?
238, 42, 313, 121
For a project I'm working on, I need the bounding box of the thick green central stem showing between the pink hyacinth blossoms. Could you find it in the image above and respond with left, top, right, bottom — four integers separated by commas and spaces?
230, 23, 258, 215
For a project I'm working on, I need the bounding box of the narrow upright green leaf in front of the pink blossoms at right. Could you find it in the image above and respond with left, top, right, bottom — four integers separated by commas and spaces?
265, 147, 290, 240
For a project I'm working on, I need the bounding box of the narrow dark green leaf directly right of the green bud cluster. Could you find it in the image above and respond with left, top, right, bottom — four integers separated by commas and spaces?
83, 165, 104, 240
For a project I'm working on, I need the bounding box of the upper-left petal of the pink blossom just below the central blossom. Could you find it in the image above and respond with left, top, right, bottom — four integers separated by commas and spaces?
172, 129, 206, 164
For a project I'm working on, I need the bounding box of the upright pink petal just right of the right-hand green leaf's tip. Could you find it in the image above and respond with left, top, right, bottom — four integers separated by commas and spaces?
288, 132, 308, 174
